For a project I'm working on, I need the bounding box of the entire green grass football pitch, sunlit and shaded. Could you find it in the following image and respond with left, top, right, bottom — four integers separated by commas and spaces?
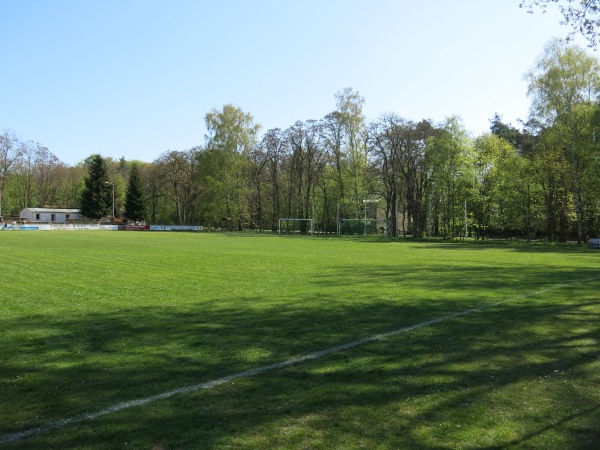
0, 231, 600, 450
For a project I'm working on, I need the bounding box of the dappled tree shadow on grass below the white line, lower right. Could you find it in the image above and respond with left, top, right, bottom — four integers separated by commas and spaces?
4, 299, 600, 448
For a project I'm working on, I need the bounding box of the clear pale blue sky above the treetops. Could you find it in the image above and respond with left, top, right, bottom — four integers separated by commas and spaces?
0, 0, 593, 165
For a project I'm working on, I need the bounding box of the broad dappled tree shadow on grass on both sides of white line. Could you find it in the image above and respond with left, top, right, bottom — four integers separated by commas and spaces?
0, 267, 600, 448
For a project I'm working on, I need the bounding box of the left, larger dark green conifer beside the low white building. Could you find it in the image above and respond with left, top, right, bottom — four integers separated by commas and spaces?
80, 154, 112, 219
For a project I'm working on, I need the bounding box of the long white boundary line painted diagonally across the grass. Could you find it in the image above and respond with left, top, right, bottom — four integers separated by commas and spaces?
0, 276, 600, 444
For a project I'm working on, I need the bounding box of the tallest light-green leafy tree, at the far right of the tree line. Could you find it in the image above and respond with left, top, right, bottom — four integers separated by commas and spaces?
526, 40, 600, 243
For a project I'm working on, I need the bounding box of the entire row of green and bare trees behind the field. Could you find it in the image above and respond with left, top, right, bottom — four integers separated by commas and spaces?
0, 40, 600, 242
